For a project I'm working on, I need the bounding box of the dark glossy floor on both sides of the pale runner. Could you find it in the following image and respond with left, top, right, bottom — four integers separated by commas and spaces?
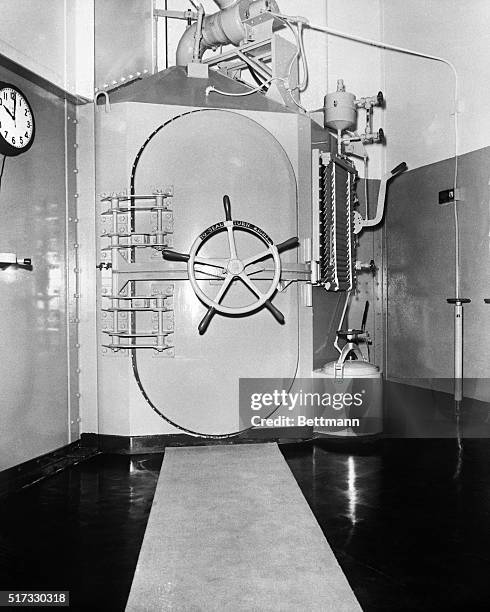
0, 440, 490, 612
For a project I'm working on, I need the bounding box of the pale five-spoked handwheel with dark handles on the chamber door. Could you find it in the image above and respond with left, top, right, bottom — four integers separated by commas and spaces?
162, 195, 299, 335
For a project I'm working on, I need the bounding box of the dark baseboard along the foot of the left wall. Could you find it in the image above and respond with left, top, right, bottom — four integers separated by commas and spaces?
0, 440, 98, 498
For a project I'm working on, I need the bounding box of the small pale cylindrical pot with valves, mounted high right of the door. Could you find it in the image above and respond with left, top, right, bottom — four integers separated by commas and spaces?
323, 79, 384, 154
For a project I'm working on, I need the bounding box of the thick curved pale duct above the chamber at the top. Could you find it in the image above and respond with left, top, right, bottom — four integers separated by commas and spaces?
176, 0, 276, 66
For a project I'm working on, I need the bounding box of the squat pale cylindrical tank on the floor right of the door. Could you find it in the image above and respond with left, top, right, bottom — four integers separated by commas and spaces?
313, 360, 383, 438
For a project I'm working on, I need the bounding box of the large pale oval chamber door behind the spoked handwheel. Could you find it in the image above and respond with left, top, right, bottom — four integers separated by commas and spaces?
126, 110, 300, 435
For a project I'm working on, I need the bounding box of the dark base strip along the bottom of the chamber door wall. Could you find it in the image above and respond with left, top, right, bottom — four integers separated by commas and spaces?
81, 427, 312, 455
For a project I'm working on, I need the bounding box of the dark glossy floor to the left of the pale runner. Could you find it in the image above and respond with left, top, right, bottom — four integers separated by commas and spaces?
0, 455, 162, 612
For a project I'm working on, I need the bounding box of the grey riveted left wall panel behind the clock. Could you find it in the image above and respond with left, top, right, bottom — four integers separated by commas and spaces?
0, 68, 78, 469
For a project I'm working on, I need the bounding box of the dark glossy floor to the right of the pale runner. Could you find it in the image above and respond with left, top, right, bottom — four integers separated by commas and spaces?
283, 439, 490, 612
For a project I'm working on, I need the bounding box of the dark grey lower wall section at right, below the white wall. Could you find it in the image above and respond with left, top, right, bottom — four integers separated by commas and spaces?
386, 148, 490, 401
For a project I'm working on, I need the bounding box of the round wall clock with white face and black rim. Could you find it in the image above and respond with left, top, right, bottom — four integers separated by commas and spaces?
0, 81, 35, 157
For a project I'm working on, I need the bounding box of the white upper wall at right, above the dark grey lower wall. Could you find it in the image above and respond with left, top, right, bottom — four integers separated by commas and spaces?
382, 0, 490, 168
